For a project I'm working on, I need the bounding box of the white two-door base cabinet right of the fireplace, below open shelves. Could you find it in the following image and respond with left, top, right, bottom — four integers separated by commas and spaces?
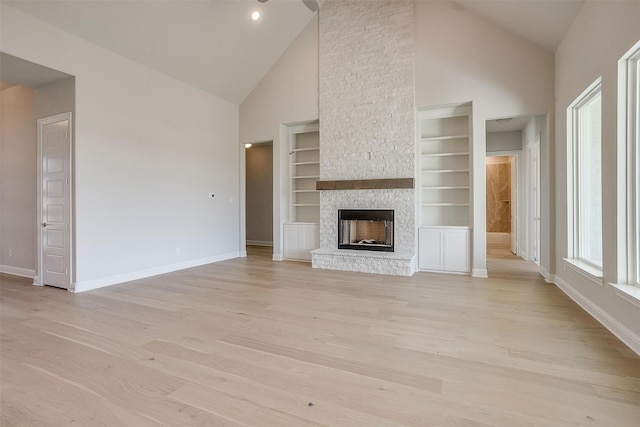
418, 227, 471, 273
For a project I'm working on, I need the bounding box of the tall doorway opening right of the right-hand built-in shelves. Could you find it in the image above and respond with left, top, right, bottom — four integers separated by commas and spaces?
486, 115, 548, 278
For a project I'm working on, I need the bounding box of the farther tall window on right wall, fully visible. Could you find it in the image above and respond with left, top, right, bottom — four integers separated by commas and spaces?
567, 79, 602, 277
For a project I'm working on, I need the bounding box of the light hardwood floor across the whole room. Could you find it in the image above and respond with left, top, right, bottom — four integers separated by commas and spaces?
0, 250, 640, 427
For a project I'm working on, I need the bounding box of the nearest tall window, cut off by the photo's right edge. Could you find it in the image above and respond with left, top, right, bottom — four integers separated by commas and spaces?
618, 42, 640, 286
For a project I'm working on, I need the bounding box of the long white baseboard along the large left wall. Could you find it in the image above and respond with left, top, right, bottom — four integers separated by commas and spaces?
70, 252, 240, 292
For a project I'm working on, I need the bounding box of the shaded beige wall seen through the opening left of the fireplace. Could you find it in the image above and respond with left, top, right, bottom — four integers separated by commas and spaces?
246, 143, 273, 245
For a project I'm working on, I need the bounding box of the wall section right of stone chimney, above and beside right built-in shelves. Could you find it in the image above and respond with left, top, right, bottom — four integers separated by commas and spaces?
416, 1, 554, 275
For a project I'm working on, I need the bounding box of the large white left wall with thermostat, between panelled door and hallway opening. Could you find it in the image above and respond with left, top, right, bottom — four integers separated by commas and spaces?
0, 4, 240, 290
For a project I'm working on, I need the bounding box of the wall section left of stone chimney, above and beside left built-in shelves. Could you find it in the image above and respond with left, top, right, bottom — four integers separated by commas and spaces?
240, 16, 318, 259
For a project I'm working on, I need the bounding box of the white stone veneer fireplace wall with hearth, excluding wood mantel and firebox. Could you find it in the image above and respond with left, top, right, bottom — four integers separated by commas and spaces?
312, 0, 415, 275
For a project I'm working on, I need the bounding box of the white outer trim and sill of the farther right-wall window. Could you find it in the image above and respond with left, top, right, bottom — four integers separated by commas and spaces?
564, 77, 603, 278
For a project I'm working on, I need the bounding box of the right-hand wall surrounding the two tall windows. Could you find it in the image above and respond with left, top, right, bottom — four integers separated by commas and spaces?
555, 1, 640, 352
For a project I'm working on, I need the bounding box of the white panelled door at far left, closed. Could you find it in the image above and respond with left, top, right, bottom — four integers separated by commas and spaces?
37, 113, 71, 289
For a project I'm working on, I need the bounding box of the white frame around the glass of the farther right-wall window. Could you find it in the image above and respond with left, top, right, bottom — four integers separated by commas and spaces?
566, 77, 603, 276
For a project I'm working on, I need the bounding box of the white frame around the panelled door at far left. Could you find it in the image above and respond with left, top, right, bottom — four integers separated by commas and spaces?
33, 112, 75, 292
